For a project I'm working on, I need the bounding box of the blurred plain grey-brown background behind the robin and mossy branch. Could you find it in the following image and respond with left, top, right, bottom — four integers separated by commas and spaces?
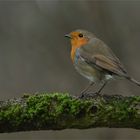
0, 0, 140, 140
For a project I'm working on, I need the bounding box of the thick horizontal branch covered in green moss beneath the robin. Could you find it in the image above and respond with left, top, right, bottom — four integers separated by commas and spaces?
0, 93, 140, 133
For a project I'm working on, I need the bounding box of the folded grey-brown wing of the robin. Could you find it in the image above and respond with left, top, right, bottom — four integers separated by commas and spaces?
79, 45, 127, 77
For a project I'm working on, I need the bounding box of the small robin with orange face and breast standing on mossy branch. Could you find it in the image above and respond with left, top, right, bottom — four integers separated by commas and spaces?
65, 29, 140, 96
